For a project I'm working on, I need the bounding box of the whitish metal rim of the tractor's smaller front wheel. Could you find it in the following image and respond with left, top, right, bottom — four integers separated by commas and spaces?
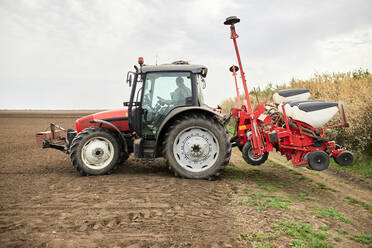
81, 137, 114, 170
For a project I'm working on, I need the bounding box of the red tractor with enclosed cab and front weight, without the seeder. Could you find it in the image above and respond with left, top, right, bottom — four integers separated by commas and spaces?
36, 57, 231, 179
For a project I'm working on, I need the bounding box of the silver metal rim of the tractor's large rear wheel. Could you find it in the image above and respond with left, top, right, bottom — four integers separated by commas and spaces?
173, 127, 220, 172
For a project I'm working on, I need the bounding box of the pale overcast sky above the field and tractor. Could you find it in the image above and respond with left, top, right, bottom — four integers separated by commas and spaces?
0, 0, 372, 109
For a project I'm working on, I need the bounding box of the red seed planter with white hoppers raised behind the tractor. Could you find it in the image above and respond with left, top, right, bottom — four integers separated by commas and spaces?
224, 16, 353, 171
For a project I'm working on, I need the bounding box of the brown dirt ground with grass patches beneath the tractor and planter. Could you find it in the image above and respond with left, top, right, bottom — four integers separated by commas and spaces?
0, 111, 372, 248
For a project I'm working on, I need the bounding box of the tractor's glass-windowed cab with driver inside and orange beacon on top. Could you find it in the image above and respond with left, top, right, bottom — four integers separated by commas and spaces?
124, 58, 212, 159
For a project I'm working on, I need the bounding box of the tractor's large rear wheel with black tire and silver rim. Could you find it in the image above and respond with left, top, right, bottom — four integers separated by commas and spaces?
163, 114, 231, 179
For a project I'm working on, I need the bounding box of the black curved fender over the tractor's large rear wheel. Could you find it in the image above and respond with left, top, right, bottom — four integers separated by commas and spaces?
156, 106, 225, 157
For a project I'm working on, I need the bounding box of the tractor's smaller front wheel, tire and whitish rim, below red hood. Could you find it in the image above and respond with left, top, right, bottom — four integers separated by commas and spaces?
70, 127, 120, 175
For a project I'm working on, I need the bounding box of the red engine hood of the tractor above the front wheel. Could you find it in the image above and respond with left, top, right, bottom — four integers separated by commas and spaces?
75, 109, 129, 133
